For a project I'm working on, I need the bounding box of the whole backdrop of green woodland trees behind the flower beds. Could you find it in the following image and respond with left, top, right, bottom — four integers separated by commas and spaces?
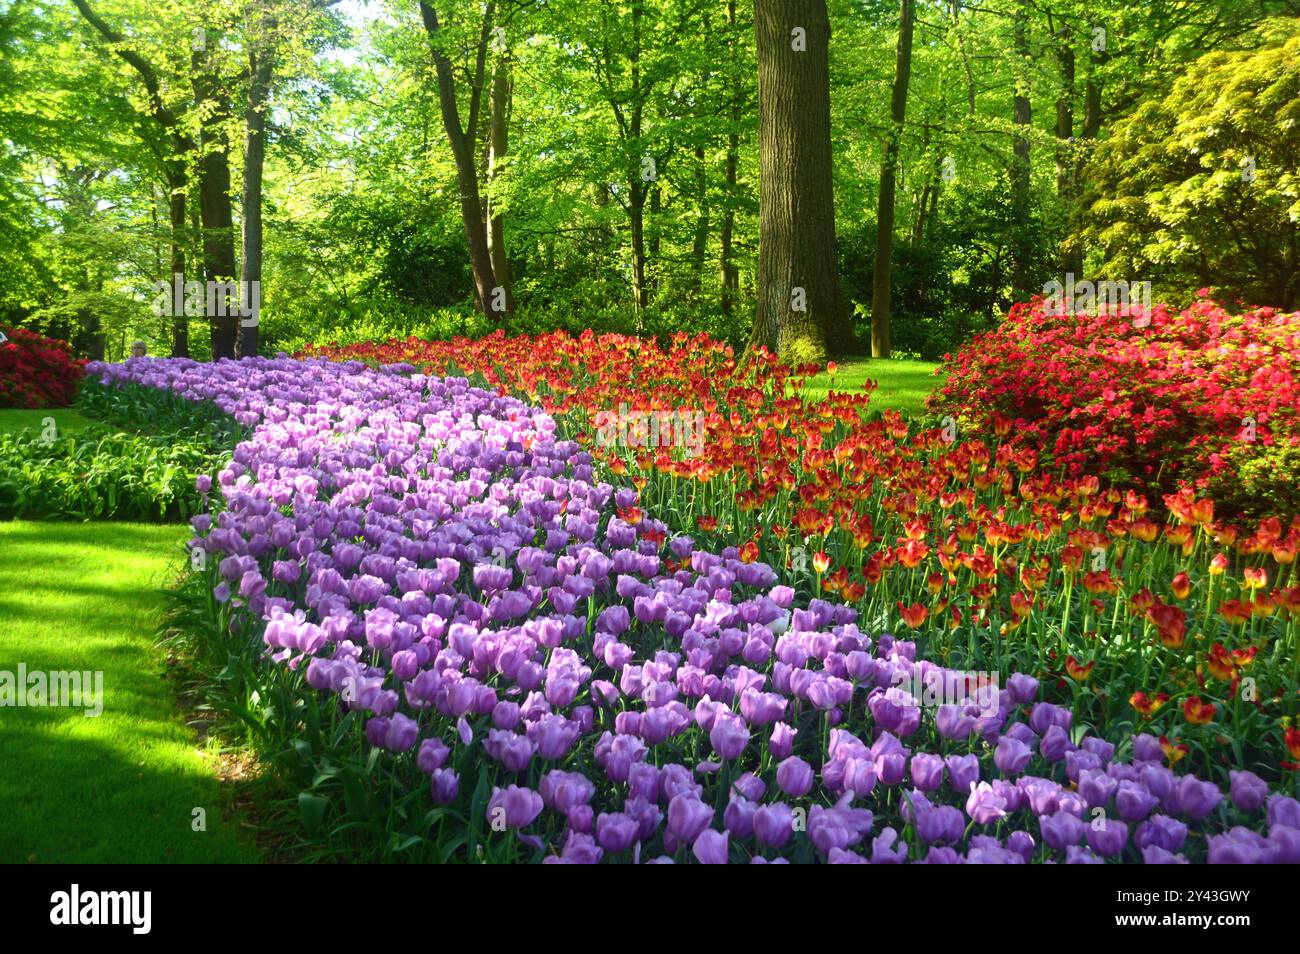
0, 0, 1300, 357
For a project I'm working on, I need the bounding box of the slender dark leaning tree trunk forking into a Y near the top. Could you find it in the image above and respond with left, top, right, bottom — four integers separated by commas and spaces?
420, 0, 504, 315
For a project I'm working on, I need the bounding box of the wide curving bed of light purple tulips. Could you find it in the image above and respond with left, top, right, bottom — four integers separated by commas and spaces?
88, 359, 1300, 863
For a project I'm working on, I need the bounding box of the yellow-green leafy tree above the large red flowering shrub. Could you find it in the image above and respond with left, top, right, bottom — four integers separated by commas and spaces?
1082, 19, 1300, 309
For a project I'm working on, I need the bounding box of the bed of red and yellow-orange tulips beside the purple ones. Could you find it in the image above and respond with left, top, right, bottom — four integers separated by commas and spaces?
299, 334, 1300, 785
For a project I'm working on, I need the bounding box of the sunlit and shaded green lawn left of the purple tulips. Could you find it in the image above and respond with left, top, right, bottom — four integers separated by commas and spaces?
0, 521, 259, 863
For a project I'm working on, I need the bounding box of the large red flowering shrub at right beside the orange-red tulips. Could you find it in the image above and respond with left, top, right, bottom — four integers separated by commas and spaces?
931, 298, 1300, 512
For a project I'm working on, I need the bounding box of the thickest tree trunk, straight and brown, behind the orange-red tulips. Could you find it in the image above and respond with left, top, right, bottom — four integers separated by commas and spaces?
749, 0, 849, 364
